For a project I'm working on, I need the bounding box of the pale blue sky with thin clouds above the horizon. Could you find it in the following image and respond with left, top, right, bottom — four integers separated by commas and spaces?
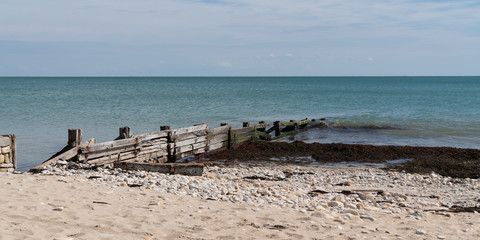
0, 0, 480, 76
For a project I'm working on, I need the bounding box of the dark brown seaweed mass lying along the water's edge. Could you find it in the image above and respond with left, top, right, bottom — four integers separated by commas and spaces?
202, 141, 480, 178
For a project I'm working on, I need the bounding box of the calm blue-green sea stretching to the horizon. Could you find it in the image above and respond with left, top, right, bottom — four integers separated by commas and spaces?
0, 76, 480, 171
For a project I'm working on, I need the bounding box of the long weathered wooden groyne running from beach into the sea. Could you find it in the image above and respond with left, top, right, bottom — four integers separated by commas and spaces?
30, 119, 322, 174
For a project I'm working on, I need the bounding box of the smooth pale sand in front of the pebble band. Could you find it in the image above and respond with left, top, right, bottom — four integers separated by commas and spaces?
0, 170, 480, 239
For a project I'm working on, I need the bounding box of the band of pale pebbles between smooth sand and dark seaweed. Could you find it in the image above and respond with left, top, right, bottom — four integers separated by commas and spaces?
40, 161, 480, 224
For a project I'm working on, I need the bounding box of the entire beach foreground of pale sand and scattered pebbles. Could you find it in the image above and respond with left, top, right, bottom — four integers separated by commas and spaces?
0, 163, 480, 239
